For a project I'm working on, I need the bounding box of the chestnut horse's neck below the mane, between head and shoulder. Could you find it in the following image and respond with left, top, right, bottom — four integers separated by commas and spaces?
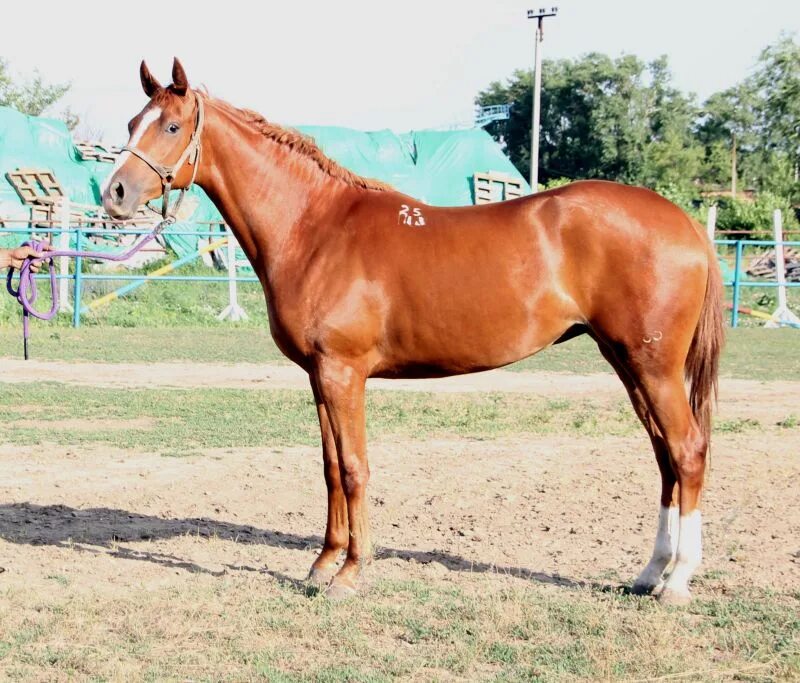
198, 107, 340, 283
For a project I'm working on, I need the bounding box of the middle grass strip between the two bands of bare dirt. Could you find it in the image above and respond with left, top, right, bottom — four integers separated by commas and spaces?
0, 383, 638, 454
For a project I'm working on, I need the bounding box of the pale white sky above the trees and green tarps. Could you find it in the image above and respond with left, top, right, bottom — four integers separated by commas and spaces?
0, 0, 800, 143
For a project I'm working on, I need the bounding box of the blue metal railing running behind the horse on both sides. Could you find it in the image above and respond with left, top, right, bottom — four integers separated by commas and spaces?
0, 227, 800, 327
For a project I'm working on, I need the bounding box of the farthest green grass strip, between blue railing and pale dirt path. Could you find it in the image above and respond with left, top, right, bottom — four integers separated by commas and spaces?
0, 321, 800, 380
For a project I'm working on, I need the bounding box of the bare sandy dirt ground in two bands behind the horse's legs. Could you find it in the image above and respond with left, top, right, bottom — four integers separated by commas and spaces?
0, 361, 800, 593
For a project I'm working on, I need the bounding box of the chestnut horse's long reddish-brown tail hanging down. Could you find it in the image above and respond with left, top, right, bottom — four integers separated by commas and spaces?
684, 226, 725, 444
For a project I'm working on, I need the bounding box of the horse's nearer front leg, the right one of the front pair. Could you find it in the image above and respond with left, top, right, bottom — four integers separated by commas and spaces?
316, 358, 372, 600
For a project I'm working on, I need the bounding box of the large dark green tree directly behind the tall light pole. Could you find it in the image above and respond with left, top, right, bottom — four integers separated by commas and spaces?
476, 53, 702, 187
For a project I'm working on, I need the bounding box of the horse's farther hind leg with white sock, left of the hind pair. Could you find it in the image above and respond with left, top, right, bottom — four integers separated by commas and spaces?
595, 340, 679, 595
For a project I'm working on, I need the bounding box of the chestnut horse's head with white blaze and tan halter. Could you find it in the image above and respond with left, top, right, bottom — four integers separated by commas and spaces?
103, 58, 203, 219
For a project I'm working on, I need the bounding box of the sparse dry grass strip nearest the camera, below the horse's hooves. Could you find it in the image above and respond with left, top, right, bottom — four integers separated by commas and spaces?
0, 575, 800, 683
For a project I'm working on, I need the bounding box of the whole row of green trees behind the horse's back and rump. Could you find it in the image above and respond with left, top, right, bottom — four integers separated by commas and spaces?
475, 36, 800, 202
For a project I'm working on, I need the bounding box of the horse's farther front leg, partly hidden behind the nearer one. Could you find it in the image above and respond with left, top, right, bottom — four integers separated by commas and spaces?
308, 375, 349, 588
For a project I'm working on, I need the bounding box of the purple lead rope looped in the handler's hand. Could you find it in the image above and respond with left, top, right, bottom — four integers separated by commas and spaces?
6, 216, 175, 360
